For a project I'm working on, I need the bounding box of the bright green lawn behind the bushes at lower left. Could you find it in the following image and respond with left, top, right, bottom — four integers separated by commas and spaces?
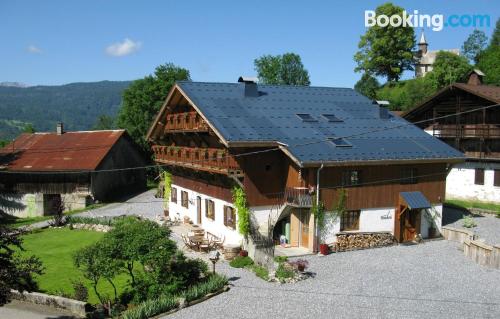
19, 228, 128, 304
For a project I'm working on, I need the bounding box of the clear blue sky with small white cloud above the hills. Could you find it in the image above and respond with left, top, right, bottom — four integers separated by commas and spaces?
0, 0, 500, 87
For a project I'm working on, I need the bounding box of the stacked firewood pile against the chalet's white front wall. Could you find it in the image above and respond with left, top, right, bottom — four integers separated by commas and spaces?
335, 232, 395, 251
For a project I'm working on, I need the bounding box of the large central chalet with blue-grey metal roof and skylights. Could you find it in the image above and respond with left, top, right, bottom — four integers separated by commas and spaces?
147, 78, 462, 251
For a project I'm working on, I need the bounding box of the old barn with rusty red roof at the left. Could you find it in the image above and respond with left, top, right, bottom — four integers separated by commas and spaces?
0, 123, 146, 217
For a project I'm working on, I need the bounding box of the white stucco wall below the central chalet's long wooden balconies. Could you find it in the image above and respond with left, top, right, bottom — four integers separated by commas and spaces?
169, 184, 243, 245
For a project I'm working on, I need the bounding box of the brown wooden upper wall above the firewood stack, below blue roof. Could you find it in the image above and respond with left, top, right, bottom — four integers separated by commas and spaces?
320, 164, 446, 210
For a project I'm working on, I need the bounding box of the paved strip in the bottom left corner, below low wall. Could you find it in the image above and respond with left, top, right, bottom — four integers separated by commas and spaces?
0, 300, 75, 319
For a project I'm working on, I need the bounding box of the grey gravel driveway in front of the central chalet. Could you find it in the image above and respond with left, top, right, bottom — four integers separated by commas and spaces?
166, 240, 500, 319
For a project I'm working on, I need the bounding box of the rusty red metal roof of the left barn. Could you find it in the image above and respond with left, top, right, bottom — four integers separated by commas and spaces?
0, 130, 125, 172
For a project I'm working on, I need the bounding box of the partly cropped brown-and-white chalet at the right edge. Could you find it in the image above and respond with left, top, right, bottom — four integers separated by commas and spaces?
402, 70, 500, 203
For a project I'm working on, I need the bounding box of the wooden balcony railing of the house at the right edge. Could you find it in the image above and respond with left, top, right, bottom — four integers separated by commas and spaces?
426, 124, 500, 138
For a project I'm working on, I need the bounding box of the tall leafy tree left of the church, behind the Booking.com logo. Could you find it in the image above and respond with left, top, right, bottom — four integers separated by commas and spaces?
354, 2, 415, 81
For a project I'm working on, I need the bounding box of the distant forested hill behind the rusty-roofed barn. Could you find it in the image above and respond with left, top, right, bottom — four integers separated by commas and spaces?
0, 81, 130, 140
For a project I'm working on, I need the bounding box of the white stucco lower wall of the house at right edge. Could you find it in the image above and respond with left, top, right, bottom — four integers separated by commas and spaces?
446, 163, 500, 203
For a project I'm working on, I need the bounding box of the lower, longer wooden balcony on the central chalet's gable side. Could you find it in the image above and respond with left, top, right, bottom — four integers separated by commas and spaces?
152, 145, 242, 176
